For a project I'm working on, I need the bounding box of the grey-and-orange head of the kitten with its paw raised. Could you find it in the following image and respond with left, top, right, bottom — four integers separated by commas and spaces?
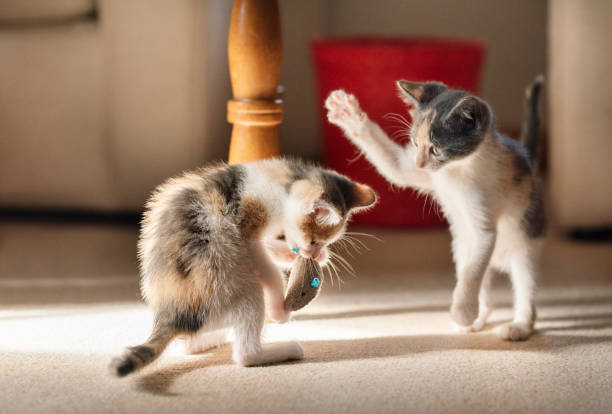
397, 80, 493, 170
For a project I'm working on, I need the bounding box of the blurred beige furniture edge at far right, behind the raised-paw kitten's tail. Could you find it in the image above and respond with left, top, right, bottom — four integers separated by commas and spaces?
548, 0, 612, 229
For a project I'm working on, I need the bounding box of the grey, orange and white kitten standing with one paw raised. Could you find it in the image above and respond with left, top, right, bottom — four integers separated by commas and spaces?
325, 77, 545, 341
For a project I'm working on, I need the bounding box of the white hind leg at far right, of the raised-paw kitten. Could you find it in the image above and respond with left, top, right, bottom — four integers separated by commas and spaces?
499, 253, 535, 341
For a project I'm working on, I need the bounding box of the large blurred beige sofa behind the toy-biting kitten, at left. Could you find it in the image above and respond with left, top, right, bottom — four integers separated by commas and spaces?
0, 0, 231, 210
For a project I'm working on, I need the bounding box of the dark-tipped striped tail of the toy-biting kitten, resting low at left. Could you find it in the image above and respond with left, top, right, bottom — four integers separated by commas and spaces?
110, 321, 176, 377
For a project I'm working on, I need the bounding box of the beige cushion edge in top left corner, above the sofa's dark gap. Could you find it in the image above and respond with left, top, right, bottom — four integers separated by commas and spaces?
0, 0, 96, 24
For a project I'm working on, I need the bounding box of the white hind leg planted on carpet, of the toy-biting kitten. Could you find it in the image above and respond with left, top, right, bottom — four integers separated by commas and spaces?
231, 286, 304, 366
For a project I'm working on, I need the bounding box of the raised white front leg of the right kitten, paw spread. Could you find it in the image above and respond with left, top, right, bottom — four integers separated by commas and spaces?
325, 90, 432, 190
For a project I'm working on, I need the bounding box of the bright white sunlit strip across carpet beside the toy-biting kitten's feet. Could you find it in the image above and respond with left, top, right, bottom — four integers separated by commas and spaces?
0, 303, 460, 355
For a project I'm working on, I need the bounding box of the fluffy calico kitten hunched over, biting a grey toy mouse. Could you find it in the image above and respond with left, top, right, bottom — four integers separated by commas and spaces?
111, 159, 376, 376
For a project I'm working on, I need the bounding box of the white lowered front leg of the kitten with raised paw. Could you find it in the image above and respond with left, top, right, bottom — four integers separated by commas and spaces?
451, 230, 496, 330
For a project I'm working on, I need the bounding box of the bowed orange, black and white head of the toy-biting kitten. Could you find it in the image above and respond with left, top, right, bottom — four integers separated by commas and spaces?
284, 169, 376, 264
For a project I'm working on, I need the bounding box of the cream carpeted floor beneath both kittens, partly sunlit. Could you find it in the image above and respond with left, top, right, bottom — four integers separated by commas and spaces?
0, 223, 612, 413
